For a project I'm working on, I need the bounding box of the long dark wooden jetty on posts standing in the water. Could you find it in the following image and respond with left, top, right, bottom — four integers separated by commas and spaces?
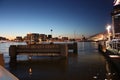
9, 42, 78, 62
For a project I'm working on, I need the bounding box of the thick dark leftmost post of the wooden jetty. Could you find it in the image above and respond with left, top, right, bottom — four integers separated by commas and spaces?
9, 45, 17, 62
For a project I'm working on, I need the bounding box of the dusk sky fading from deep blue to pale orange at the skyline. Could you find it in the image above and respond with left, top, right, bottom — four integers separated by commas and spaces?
0, 0, 114, 38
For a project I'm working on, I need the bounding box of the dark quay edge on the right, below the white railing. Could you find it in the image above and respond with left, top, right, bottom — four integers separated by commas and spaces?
98, 42, 120, 73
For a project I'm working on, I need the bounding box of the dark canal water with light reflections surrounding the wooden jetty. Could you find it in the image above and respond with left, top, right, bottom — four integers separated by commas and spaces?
0, 42, 120, 80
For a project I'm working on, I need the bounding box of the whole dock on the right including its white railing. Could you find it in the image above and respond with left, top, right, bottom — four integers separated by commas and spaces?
98, 41, 120, 73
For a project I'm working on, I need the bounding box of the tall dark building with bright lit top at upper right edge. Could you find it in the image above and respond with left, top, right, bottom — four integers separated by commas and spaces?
112, 0, 120, 38
